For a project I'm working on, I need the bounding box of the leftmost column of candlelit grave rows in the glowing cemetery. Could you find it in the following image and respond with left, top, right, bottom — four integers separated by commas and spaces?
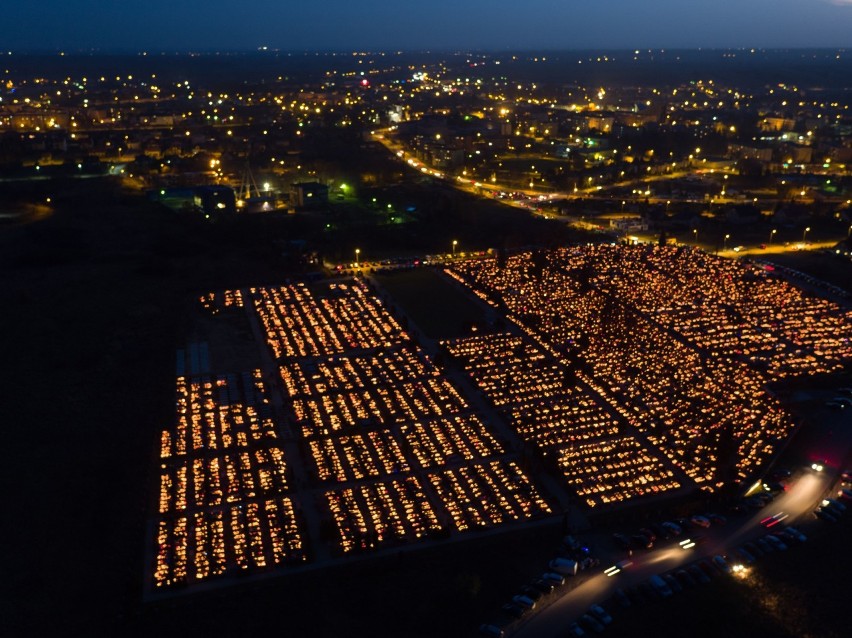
153, 370, 306, 588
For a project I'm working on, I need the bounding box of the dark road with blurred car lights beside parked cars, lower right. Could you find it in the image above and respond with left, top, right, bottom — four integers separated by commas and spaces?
506, 402, 852, 638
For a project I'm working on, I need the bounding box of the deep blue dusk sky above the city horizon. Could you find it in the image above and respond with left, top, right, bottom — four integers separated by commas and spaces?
5, 0, 852, 52
